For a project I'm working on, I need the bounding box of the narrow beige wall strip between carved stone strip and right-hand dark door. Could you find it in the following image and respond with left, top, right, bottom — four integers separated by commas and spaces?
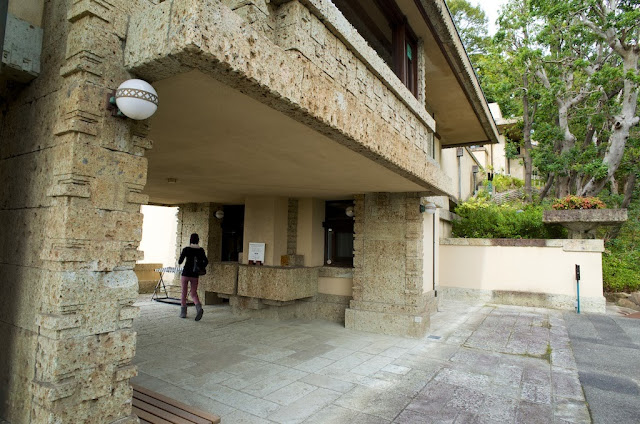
296, 199, 324, 266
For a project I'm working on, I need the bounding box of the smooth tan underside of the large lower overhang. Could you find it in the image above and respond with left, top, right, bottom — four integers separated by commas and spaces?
144, 70, 432, 205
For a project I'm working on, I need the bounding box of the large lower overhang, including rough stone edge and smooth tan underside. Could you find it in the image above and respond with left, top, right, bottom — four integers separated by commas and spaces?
125, 0, 453, 204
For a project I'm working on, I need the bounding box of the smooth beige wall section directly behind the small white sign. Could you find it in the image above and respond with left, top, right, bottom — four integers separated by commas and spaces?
242, 196, 288, 266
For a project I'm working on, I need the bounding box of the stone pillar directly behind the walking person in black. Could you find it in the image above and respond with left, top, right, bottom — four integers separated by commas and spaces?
174, 203, 222, 302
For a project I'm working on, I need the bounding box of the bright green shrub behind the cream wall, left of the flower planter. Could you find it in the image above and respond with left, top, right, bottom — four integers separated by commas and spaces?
453, 198, 566, 239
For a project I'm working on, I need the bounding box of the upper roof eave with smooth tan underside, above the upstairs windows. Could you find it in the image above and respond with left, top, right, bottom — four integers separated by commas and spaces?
397, 0, 498, 148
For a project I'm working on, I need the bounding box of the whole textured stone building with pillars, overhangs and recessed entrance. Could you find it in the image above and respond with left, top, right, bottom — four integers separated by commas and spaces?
0, 0, 498, 423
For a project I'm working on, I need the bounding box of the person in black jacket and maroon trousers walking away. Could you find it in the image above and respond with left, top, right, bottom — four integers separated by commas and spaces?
178, 233, 209, 321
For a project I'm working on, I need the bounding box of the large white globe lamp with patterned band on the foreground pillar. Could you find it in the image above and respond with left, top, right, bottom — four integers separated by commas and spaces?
107, 79, 158, 120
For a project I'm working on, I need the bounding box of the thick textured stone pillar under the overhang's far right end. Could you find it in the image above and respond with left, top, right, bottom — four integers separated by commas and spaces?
345, 193, 435, 337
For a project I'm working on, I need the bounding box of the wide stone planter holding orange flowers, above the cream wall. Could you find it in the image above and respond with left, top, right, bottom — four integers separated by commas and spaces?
542, 209, 627, 239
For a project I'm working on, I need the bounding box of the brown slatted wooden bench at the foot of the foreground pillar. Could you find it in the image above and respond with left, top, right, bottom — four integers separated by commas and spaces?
131, 384, 220, 424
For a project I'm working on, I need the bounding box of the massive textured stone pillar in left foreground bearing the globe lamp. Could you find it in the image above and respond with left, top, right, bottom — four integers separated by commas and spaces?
0, 0, 151, 423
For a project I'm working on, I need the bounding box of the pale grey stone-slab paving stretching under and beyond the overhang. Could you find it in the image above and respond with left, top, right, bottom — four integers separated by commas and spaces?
133, 300, 592, 424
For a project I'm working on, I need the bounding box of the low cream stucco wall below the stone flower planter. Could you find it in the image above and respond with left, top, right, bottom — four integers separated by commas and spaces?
439, 239, 604, 312
